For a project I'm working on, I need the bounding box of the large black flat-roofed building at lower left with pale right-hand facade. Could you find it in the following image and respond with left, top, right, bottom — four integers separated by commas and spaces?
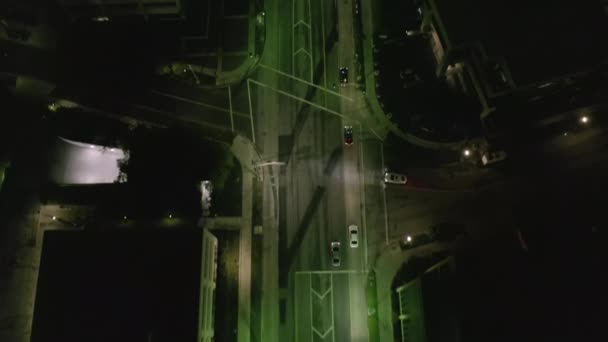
31, 229, 217, 342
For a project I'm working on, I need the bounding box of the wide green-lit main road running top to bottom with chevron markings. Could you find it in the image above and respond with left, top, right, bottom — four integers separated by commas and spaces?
250, 0, 372, 341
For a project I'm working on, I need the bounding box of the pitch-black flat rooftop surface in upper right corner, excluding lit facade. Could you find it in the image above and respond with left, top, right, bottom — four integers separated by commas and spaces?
434, 0, 608, 84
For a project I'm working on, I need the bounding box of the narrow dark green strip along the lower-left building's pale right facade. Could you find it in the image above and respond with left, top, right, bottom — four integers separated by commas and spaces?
213, 230, 240, 342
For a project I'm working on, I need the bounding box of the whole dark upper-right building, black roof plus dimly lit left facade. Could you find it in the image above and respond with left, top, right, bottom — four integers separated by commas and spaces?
420, 0, 608, 118
